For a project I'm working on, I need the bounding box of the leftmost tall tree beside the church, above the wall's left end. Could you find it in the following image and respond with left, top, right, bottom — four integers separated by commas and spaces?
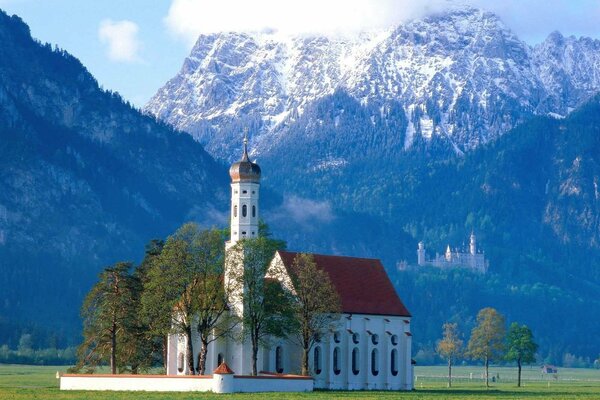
78, 262, 136, 374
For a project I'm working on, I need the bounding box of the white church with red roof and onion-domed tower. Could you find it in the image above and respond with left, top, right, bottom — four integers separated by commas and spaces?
167, 138, 413, 390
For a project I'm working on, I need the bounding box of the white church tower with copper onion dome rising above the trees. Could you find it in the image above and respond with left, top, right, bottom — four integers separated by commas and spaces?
227, 131, 260, 247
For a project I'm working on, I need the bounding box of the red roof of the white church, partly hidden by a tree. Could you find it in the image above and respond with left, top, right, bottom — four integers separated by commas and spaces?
278, 251, 411, 317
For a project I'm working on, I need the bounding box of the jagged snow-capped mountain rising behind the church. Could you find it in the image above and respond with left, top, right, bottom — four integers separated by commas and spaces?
145, 7, 600, 160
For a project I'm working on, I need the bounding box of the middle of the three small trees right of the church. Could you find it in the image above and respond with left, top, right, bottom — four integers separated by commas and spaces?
467, 307, 505, 387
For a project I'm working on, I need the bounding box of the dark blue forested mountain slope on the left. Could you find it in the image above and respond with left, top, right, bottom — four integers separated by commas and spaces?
0, 11, 228, 346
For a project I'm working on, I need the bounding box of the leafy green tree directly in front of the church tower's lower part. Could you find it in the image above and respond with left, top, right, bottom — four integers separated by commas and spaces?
226, 237, 294, 375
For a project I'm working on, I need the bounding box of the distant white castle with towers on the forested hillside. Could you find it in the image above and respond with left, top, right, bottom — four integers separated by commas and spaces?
417, 232, 489, 274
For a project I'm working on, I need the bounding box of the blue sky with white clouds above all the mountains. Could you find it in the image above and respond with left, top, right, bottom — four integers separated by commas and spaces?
0, 0, 600, 107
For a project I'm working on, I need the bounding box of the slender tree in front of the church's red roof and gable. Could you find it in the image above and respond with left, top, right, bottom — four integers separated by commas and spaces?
290, 253, 341, 375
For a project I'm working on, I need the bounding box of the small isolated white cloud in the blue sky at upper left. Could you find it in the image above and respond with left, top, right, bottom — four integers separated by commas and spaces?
98, 19, 141, 63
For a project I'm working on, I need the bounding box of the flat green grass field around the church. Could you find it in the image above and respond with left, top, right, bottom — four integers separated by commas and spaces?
0, 364, 600, 400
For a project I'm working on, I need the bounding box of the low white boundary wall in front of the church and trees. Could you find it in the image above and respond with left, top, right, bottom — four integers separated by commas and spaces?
60, 374, 314, 393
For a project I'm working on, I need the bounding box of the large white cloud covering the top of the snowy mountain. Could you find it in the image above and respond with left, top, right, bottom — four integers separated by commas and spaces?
165, 0, 448, 43
